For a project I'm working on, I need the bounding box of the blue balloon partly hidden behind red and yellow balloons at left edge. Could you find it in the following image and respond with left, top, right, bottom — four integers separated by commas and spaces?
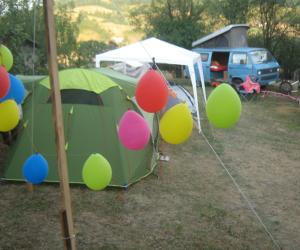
0, 74, 26, 104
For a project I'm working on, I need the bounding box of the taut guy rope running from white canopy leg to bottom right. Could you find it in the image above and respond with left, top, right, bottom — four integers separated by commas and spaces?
201, 133, 282, 249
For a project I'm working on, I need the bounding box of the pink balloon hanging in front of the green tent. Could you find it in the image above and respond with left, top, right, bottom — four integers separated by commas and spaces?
118, 110, 150, 150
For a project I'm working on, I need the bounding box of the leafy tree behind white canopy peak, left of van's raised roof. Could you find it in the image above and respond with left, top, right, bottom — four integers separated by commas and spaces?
130, 0, 204, 48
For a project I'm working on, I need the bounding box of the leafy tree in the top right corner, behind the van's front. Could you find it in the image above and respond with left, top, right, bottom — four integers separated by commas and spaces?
249, 0, 300, 78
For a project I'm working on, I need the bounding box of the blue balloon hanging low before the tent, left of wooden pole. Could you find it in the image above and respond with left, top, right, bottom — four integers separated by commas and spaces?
23, 154, 49, 184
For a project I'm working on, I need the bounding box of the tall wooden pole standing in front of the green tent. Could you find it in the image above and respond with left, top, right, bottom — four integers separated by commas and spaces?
43, 0, 76, 250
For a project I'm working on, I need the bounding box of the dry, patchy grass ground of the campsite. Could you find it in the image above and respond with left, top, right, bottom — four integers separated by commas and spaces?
0, 85, 300, 250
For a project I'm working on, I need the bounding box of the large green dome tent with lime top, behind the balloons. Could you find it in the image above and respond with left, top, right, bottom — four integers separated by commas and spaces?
4, 69, 158, 187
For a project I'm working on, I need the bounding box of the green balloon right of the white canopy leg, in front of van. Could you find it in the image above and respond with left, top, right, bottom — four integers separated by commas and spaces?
206, 83, 242, 128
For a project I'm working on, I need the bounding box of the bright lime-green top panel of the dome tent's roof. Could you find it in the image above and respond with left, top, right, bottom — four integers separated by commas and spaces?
40, 69, 119, 94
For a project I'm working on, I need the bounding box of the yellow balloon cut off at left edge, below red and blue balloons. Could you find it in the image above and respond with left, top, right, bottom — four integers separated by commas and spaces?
0, 99, 20, 132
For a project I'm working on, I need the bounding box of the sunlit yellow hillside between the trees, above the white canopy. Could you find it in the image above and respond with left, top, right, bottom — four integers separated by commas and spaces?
68, 0, 147, 44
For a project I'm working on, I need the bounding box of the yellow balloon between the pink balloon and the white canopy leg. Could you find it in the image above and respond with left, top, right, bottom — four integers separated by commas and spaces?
159, 103, 193, 144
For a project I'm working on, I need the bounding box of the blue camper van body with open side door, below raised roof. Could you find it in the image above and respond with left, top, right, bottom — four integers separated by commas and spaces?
193, 47, 280, 86
